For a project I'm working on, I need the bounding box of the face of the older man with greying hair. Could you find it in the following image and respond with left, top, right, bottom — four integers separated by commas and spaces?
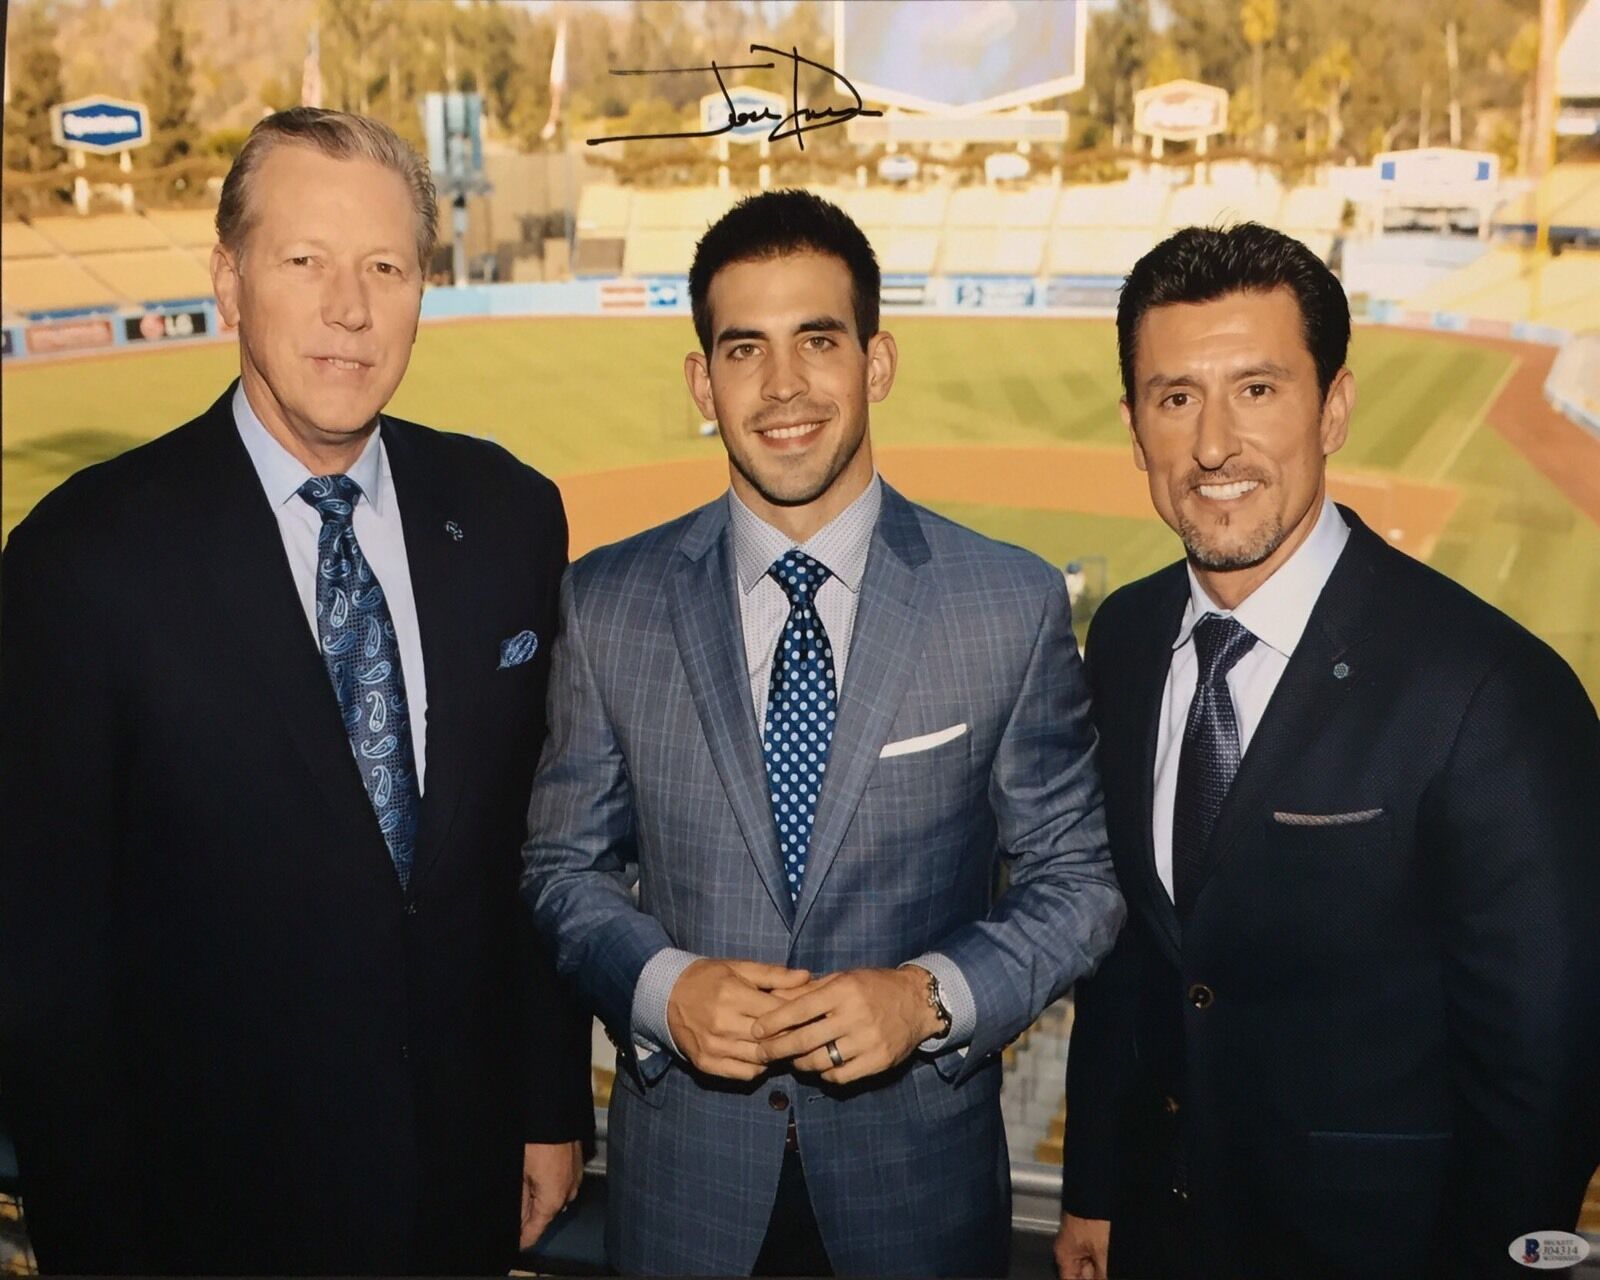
211, 144, 422, 474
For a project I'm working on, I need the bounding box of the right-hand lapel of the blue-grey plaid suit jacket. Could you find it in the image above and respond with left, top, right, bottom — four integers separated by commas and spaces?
795, 485, 936, 933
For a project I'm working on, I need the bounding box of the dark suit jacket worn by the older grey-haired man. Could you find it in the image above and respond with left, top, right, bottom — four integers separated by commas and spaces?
0, 390, 594, 1274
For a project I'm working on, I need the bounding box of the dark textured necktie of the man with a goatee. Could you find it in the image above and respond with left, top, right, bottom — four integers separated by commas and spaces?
1173, 613, 1256, 920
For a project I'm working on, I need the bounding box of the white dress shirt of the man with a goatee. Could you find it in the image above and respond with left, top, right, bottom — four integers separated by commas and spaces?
1150, 498, 1350, 898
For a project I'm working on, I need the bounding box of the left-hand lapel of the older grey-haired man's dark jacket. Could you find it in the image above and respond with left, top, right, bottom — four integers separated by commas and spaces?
183, 387, 400, 891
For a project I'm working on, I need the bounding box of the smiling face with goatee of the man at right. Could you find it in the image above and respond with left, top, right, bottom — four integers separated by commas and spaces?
1122, 288, 1355, 608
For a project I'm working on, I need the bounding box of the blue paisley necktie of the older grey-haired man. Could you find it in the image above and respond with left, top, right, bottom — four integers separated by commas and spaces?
299, 475, 421, 890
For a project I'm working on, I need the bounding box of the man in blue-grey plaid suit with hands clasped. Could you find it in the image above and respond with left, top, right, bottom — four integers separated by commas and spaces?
523, 190, 1123, 1275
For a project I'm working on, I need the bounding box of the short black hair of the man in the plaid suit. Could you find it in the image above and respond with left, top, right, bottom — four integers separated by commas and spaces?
690, 187, 882, 355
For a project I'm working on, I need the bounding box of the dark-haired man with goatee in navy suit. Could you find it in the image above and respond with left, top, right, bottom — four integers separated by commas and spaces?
1056, 224, 1600, 1280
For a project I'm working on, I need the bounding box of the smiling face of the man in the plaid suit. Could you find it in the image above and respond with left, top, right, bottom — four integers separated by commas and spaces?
683, 253, 896, 541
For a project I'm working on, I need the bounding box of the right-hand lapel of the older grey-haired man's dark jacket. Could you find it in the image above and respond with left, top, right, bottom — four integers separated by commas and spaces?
382, 418, 467, 891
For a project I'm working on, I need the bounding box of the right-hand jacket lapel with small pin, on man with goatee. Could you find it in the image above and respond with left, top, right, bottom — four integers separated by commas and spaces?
1195, 507, 1376, 910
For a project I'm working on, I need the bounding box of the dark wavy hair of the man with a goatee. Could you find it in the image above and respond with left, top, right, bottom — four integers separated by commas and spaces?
1117, 222, 1350, 408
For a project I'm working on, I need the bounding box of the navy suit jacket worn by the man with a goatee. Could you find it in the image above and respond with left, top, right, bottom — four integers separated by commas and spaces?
1062, 510, 1600, 1280
